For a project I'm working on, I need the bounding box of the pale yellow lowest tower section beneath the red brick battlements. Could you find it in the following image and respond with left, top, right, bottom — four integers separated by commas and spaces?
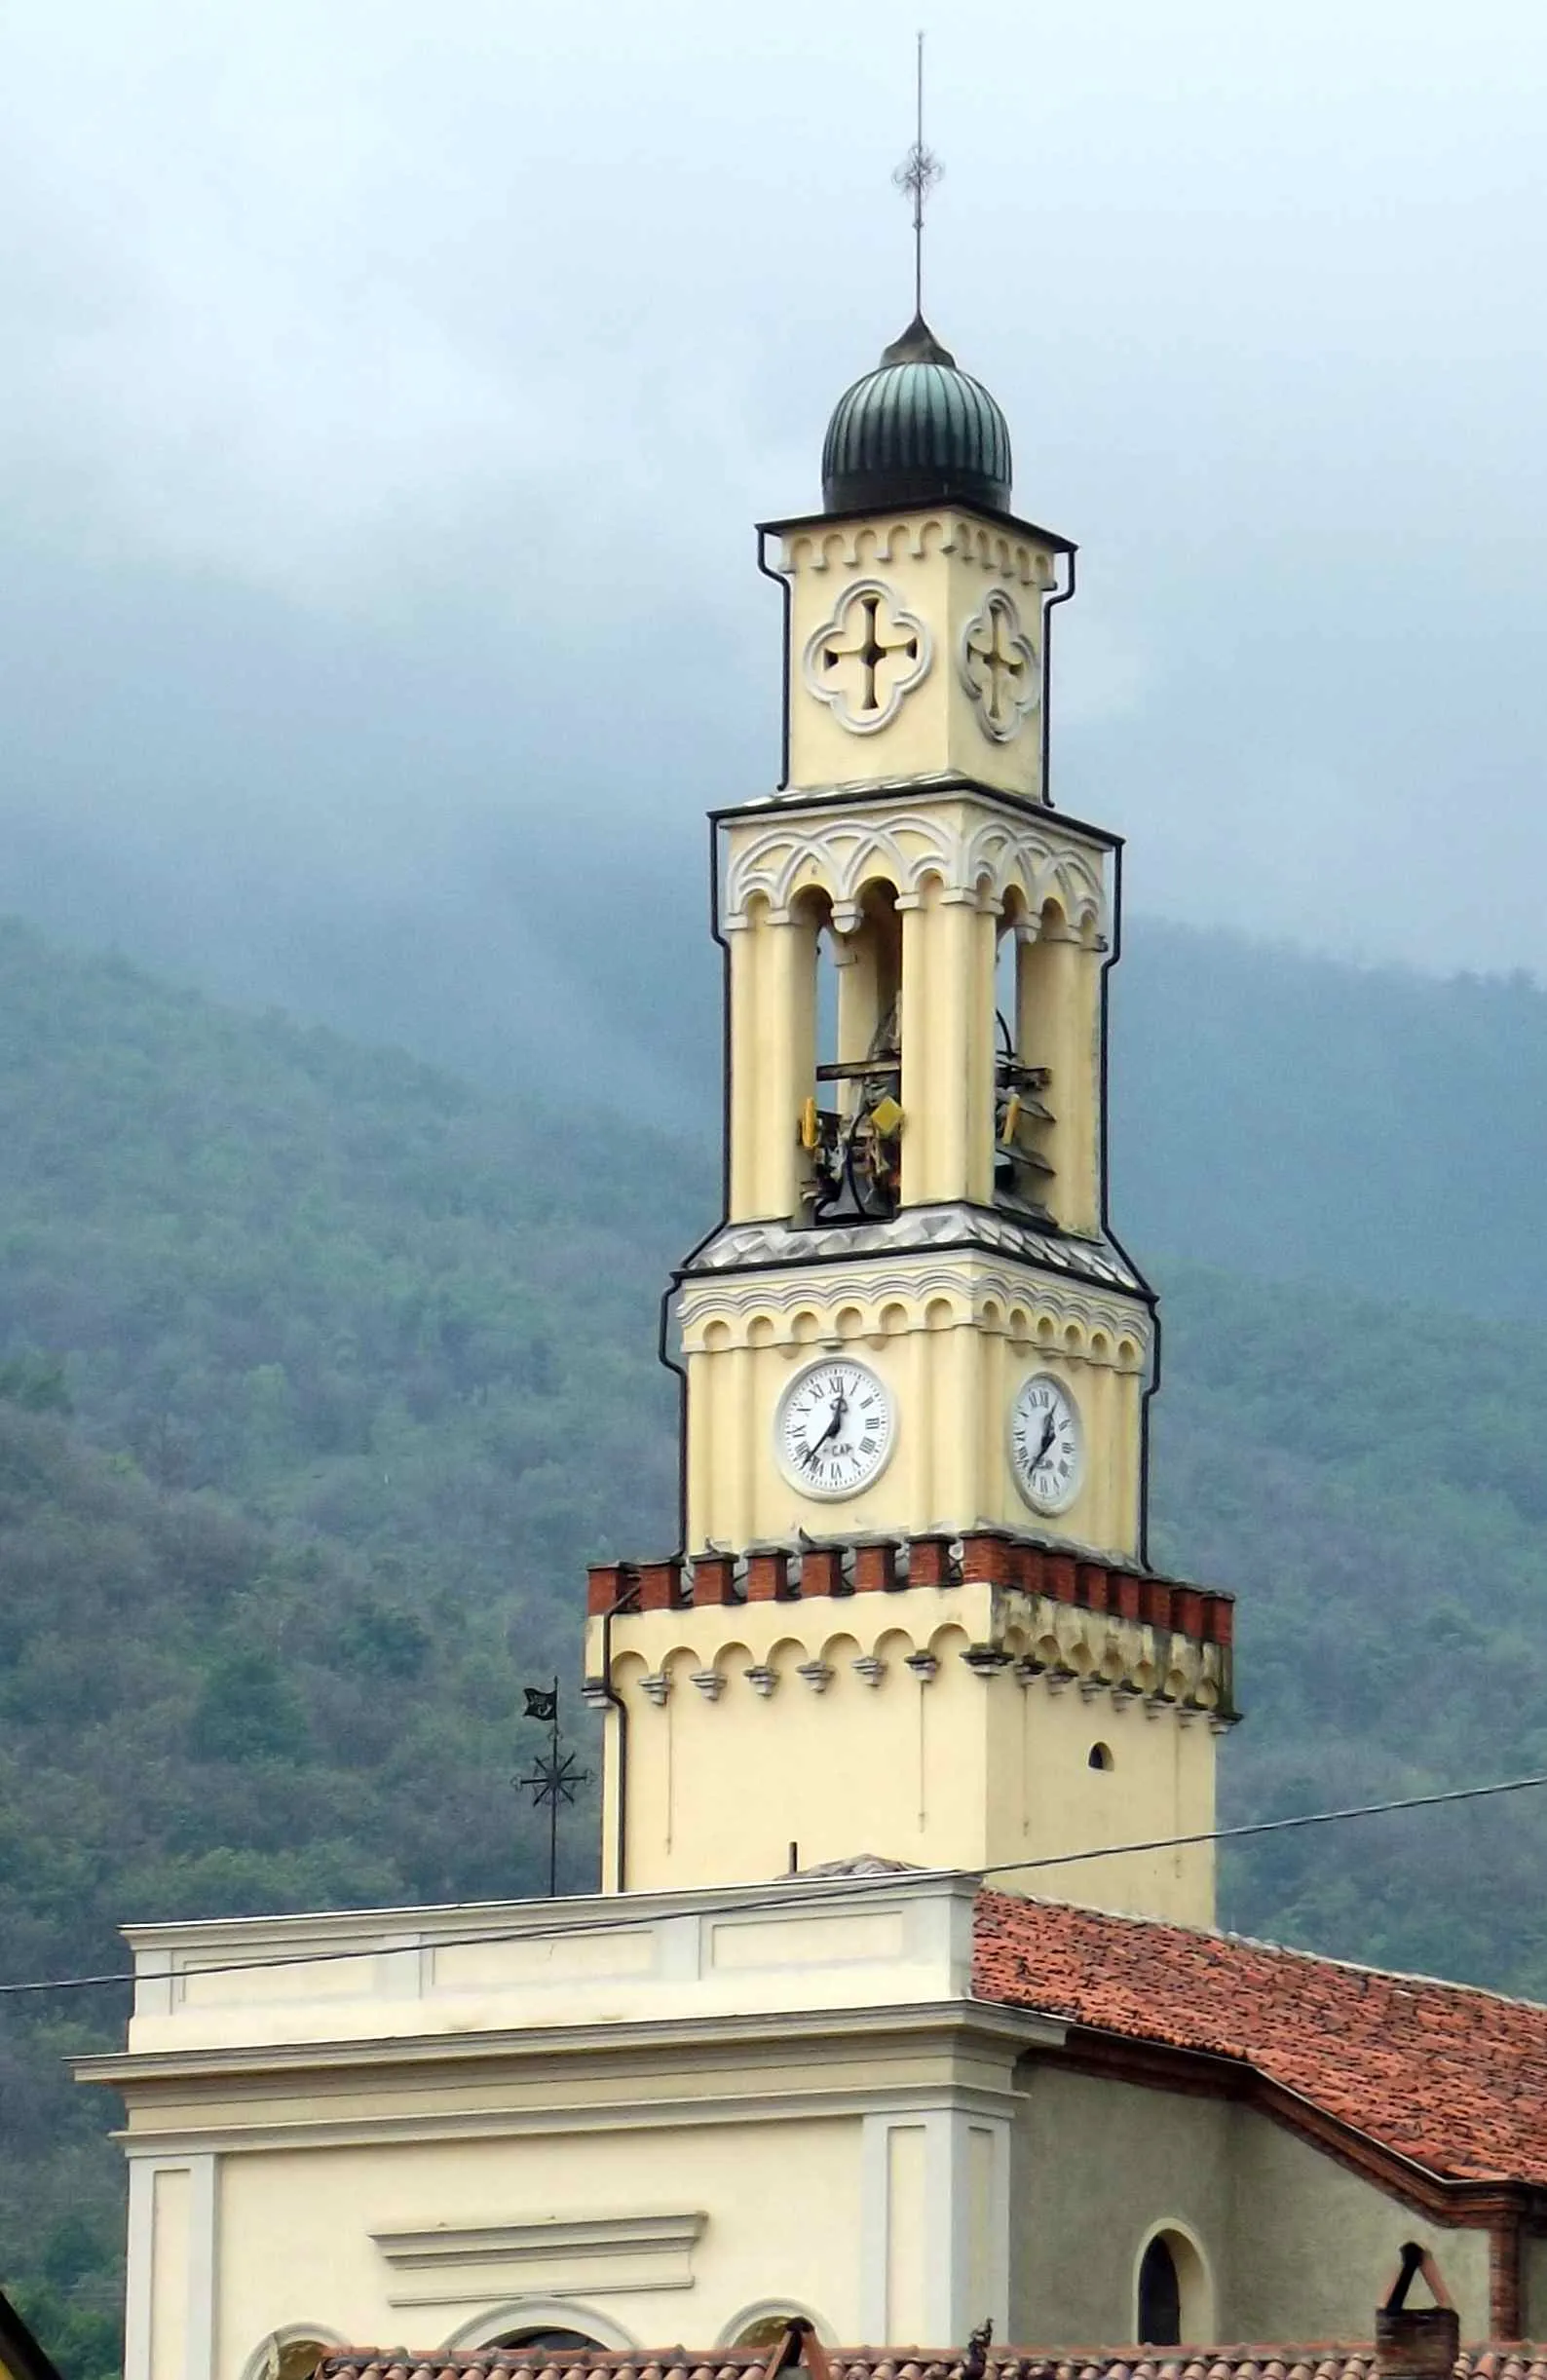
590, 1580, 1219, 1923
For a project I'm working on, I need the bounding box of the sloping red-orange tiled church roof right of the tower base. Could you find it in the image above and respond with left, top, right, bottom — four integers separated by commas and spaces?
973, 1892, 1547, 2199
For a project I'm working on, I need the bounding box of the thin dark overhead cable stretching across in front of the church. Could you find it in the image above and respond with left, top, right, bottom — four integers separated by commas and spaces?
0, 1773, 1547, 1999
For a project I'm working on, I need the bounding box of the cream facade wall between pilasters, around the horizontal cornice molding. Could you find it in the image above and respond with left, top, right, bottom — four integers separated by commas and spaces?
210, 2111, 859, 2380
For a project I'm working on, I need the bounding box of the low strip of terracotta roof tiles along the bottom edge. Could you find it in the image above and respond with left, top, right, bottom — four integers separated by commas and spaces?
317, 2342, 1547, 2380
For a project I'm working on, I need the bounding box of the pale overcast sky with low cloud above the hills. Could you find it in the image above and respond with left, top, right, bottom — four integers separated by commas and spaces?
0, 0, 1547, 1003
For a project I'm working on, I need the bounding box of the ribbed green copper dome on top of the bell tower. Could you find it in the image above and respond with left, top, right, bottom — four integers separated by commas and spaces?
821, 314, 1009, 511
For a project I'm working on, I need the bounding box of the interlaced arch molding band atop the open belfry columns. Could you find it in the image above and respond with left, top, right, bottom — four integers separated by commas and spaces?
721, 805, 1112, 942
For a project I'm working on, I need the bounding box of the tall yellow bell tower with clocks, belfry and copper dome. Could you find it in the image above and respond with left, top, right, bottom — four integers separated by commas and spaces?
578, 317, 1235, 1923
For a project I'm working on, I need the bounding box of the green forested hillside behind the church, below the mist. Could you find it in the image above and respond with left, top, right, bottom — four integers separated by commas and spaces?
0, 926, 1547, 2380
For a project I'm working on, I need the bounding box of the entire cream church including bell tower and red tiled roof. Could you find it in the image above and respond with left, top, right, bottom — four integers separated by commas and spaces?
81, 321, 1547, 2380
